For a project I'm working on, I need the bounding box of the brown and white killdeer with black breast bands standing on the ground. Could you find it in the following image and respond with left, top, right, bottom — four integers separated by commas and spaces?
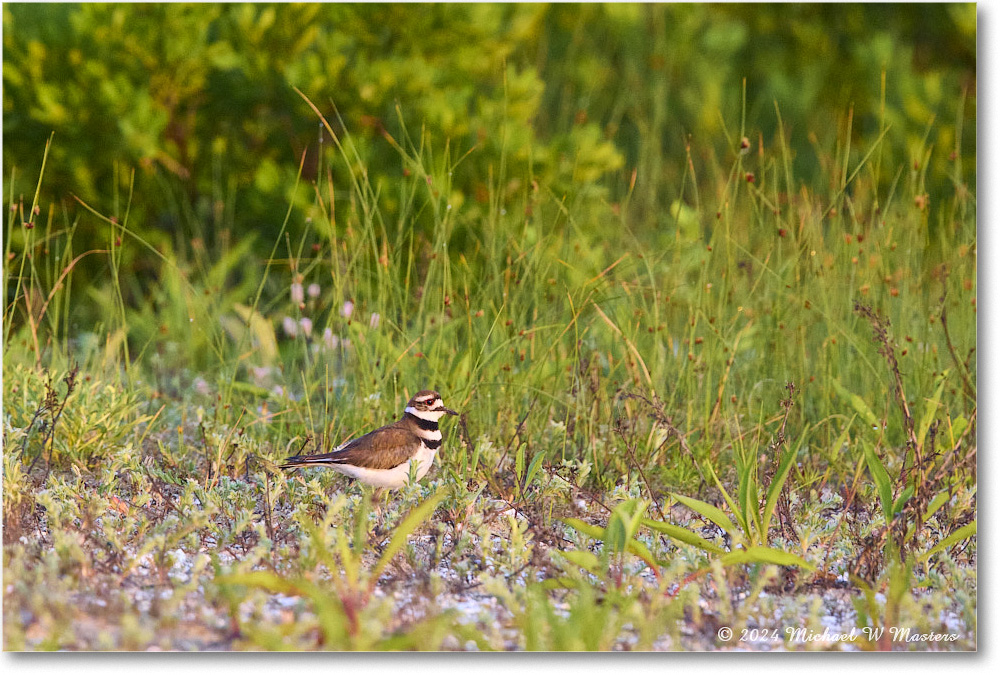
281, 389, 458, 489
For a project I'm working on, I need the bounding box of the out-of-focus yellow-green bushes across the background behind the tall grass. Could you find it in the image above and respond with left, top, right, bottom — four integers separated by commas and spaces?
3, 3, 976, 254
